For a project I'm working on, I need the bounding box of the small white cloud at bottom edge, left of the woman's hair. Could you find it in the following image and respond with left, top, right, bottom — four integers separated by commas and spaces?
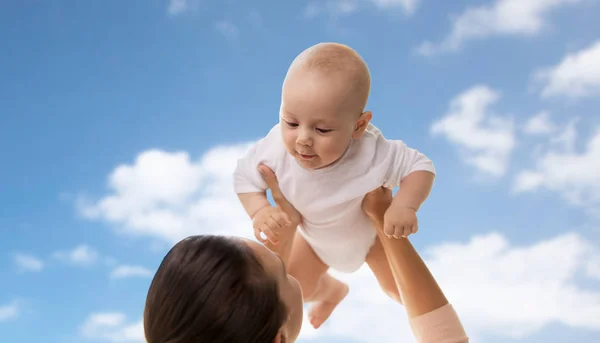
80, 312, 145, 343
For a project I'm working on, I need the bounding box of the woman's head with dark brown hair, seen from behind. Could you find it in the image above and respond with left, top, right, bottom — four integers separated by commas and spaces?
144, 236, 302, 343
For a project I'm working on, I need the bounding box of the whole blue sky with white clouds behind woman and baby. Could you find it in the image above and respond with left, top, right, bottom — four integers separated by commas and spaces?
0, 0, 600, 343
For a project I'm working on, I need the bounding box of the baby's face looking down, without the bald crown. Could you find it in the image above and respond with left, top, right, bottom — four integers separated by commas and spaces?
280, 72, 361, 169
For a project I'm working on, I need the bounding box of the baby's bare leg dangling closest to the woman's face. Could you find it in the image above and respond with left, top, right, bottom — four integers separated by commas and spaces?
288, 233, 348, 329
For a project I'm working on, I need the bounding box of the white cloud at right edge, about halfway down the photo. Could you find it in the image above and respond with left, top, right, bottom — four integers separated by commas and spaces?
513, 126, 600, 211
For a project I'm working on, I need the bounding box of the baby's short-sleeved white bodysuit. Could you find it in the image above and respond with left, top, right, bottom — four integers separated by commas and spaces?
234, 124, 435, 273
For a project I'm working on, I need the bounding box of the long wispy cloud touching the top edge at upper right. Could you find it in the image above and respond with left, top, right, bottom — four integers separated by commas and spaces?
417, 0, 582, 56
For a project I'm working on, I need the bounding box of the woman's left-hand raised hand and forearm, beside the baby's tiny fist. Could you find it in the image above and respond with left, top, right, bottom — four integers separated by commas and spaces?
258, 164, 302, 265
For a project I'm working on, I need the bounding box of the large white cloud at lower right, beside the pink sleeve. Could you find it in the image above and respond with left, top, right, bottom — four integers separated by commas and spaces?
428, 233, 600, 338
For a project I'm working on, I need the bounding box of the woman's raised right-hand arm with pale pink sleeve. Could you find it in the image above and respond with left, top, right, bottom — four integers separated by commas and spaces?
363, 188, 468, 343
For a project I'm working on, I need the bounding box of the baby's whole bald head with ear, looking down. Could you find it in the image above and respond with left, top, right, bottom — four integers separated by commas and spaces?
280, 43, 371, 169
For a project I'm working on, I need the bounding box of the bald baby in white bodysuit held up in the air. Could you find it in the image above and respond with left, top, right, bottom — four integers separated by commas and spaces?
234, 43, 435, 328
